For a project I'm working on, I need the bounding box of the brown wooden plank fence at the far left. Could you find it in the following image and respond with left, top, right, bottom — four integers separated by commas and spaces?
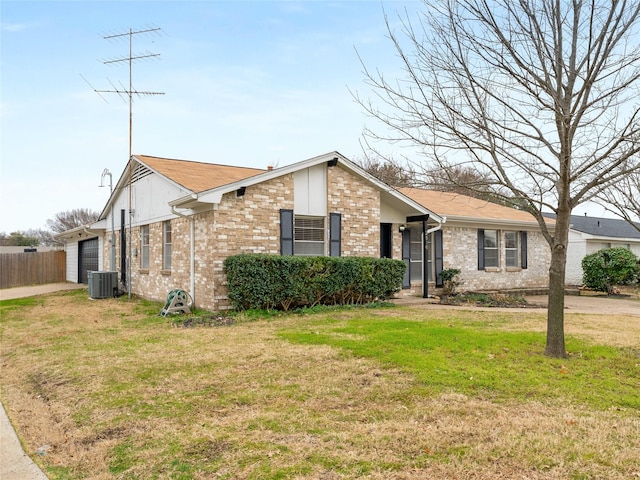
0, 250, 66, 288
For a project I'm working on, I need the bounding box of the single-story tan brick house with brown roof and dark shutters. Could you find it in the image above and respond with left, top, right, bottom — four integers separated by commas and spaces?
59, 152, 550, 310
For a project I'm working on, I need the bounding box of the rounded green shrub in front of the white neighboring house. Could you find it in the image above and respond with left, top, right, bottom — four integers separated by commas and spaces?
582, 247, 640, 295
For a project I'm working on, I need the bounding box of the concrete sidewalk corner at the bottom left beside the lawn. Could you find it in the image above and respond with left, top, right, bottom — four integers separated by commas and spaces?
0, 403, 48, 480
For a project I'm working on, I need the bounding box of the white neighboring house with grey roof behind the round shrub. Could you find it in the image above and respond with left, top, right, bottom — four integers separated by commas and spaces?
544, 213, 640, 285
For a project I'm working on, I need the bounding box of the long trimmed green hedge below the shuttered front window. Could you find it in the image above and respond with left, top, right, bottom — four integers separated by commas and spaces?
224, 254, 406, 311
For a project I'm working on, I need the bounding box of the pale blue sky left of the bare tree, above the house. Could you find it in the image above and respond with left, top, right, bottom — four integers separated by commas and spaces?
0, 0, 420, 233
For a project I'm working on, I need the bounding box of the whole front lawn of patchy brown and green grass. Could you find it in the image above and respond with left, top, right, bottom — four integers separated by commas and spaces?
0, 291, 640, 479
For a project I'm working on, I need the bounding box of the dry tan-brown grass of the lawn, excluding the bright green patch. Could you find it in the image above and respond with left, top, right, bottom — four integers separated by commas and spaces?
0, 295, 640, 479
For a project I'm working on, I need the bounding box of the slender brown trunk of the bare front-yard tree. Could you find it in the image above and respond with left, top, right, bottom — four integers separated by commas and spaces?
544, 210, 571, 358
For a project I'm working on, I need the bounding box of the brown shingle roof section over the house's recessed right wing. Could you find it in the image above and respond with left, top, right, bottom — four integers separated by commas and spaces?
400, 188, 537, 224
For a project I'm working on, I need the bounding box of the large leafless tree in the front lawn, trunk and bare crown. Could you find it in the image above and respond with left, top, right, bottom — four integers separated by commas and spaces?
356, 0, 640, 357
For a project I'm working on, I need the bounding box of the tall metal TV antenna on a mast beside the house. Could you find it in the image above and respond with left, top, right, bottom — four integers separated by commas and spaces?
82, 27, 164, 298
